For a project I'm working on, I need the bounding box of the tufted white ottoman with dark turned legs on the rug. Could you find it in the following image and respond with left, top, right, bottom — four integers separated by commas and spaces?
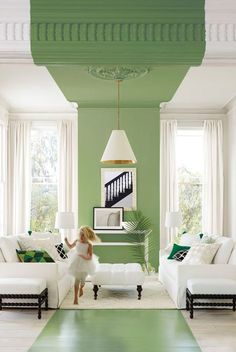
91, 263, 145, 299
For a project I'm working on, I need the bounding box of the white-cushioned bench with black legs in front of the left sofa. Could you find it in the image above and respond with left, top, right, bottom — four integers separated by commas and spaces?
0, 278, 48, 319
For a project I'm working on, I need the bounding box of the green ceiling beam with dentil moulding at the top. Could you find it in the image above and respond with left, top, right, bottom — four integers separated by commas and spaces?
31, 0, 205, 66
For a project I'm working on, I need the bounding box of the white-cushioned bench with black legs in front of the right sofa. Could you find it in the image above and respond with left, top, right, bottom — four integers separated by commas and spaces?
186, 279, 236, 319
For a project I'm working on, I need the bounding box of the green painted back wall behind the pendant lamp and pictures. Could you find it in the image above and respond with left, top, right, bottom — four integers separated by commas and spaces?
79, 108, 159, 266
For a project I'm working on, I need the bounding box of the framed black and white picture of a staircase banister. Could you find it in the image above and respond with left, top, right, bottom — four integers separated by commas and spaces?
101, 168, 137, 210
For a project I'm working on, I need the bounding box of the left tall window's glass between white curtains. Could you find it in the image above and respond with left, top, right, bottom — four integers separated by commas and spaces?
31, 126, 57, 231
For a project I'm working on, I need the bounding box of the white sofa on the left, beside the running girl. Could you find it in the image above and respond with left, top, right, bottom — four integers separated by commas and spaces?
0, 235, 72, 308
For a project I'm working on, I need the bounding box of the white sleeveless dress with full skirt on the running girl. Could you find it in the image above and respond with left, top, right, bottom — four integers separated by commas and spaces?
69, 241, 98, 278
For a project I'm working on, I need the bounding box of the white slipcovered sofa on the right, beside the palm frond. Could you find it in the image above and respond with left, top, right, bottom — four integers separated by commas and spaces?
159, 236, 236, 309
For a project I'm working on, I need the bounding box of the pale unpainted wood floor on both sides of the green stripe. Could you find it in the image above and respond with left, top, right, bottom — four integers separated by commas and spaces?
0, 309, 236, 352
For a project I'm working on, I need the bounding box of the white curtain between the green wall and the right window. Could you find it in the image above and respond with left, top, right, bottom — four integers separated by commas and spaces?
160, 120, 178, 249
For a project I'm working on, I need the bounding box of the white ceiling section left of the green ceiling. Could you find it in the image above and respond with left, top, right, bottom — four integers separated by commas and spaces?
0, 64, 75, 112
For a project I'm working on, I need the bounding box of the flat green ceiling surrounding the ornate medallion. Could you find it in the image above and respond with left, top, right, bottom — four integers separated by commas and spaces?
48, 65, 188, 108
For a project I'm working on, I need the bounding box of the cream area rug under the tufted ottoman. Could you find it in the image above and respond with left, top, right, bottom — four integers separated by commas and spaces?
60, 276, 175, 309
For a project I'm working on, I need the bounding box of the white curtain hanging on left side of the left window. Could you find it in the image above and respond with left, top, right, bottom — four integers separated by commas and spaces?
6, 121, 31, 235
